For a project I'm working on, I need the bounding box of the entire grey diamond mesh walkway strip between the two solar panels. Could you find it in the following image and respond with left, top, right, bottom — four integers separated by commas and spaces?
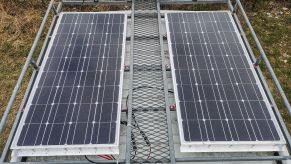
131, 0, 170, 163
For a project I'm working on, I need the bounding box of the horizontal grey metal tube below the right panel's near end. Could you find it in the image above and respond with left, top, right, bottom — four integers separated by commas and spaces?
176, 156, 291, 162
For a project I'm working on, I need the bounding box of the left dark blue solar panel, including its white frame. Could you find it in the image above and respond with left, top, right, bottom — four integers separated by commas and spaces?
14, 13, 126, 155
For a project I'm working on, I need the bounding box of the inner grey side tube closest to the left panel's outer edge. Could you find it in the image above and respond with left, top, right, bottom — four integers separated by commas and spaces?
0, 2, 62, 163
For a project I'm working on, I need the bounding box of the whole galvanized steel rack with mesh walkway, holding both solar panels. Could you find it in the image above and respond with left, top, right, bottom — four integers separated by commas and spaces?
0, 0, 291, 163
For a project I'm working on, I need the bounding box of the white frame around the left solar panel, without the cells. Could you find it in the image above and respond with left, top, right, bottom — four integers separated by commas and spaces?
11, 12, 127, 156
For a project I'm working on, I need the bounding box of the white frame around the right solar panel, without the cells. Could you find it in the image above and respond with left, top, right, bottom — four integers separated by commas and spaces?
165, 11, 286, 152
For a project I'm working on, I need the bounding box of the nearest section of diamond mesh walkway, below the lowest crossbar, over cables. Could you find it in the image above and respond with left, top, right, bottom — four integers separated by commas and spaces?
131, 110, 170, 163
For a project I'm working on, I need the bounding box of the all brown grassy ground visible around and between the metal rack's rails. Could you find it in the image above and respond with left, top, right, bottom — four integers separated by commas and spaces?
0, 0, 291, 152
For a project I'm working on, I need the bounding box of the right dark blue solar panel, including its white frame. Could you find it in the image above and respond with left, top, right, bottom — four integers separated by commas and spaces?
166, 12, 285, 152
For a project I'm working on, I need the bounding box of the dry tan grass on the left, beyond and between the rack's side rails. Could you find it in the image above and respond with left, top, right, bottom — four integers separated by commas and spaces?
0, 0, 46, 154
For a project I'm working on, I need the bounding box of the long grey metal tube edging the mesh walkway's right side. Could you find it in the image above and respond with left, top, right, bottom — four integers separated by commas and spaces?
157, 0, 175, 163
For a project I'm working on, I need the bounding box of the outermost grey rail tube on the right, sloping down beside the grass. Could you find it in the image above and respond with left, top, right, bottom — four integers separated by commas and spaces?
236, 0, 291, 116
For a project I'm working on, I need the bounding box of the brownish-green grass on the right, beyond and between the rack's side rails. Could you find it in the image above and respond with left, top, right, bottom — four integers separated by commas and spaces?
241, 0, 291, 131
